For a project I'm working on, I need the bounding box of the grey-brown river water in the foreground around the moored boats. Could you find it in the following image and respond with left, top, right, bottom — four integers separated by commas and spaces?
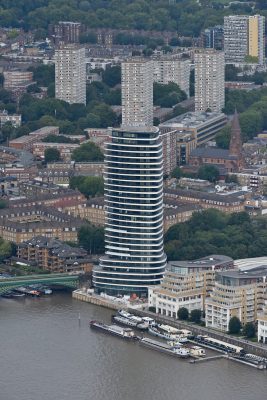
0, 294, 267, 400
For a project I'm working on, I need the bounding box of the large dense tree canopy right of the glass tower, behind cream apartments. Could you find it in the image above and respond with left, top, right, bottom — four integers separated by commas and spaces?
164, 209, 267, 260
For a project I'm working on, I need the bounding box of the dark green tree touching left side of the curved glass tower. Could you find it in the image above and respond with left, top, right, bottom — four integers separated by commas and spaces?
78, 224, 105, 254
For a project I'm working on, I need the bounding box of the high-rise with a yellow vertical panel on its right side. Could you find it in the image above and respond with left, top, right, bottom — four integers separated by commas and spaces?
224, 15, 265, 64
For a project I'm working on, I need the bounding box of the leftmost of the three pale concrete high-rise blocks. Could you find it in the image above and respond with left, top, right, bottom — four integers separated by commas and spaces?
55, 44, 86, 104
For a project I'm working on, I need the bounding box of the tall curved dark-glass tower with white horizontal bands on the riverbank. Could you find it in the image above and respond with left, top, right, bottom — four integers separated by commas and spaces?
93, 127, 166, 295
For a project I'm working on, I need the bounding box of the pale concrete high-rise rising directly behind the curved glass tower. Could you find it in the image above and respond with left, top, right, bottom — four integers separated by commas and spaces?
121, 57, 153, 127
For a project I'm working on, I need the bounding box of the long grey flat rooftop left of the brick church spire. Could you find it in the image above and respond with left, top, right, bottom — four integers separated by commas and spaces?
159, 111, 226, 128
